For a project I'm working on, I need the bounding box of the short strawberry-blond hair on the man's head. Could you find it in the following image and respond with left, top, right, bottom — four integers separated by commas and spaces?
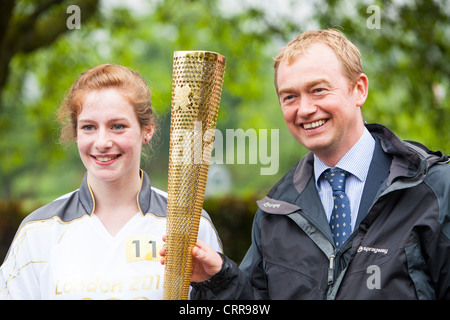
274, 29, 364, 91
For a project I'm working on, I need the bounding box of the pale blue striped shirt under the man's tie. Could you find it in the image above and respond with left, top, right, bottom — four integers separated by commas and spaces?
314, 128, 375, 231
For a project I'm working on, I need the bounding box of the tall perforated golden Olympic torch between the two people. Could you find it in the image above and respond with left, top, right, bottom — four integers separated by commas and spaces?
163, 51, 226, 300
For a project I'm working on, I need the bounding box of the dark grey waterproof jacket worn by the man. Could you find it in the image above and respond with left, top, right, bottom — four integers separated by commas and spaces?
191, 124, 450, 299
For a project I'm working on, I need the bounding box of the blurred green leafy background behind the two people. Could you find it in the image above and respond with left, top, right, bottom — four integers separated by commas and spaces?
0, 0, 450, 262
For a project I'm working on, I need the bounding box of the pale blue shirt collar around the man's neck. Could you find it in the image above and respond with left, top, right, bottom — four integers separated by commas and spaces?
314, 128, 375, 184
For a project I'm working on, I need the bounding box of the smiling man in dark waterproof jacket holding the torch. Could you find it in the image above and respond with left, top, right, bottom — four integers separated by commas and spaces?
162, 30, 450, 299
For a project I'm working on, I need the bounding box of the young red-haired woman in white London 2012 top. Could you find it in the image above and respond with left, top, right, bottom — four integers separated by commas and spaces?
0, 64, 221, 299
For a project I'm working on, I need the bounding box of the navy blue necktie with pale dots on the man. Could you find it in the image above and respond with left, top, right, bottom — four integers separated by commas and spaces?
324, 169, 352, 248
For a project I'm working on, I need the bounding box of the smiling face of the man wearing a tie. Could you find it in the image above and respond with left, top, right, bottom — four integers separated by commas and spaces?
277, 43, 368, 166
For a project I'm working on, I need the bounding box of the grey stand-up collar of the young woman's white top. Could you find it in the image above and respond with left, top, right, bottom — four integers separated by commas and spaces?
79, 170, 151, 215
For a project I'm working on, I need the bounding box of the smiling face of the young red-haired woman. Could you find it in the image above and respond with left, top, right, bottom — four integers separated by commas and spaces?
77, 88, 143, 182
